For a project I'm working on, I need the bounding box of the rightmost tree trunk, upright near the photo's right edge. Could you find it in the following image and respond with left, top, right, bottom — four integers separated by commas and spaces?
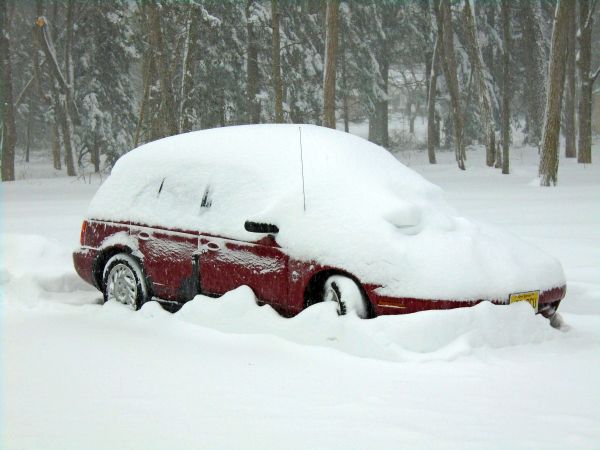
577, 0, 593, 164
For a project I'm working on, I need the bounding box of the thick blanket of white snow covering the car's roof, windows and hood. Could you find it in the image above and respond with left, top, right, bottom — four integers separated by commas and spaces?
89, 125, 564, 300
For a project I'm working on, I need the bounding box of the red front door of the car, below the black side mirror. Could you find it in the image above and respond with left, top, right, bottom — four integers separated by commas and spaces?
199, 236, 289, 306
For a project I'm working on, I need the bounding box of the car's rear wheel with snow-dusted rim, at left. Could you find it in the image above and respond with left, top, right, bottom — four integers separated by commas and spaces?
102, 253, 148, 311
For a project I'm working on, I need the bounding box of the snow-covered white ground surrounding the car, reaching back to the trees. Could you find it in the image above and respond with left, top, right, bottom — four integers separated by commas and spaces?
0, 142, 600, 449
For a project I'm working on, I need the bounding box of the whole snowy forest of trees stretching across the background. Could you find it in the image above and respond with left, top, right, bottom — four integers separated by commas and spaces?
0, 0, 600, 184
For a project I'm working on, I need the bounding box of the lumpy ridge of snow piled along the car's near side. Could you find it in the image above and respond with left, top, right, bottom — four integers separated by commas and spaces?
140, 286, 563, 362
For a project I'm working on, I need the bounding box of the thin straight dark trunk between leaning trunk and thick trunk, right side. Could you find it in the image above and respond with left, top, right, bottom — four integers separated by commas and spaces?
500, 0, 512, 175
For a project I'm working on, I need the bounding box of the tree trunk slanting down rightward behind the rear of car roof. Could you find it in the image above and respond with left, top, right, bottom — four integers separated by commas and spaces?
147, 0, 179, 137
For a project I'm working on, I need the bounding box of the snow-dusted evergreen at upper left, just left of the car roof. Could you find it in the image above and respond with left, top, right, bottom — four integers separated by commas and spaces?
75, 0, 138, 172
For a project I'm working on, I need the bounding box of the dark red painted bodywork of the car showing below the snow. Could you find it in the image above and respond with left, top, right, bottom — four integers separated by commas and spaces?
73, 220, 566, 317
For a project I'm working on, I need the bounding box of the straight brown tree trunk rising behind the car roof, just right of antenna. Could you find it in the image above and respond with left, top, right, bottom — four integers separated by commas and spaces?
323, 0, 339, 129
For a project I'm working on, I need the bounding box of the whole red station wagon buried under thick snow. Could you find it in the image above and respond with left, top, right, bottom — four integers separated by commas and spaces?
73, 125, 566, 318
